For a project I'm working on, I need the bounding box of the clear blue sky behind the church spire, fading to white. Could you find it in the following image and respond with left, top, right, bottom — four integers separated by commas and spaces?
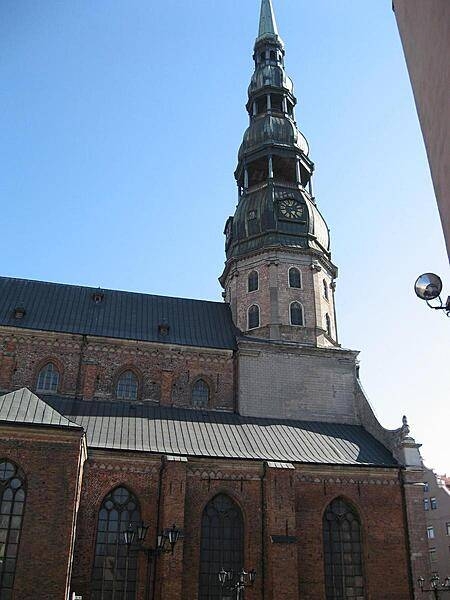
0, 0, 450, 472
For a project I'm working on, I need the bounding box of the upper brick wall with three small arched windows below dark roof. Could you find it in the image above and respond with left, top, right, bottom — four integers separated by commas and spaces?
0, 329, 234, 410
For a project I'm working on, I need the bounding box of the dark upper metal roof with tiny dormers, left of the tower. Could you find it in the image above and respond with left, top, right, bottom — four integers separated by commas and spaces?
0, 277, 236, 349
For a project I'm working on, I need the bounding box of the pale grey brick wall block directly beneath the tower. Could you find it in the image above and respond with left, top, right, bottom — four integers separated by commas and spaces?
238, 341, 359, 423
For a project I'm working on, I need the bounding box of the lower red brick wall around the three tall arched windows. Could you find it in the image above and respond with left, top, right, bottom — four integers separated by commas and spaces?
67, 458, 410, 600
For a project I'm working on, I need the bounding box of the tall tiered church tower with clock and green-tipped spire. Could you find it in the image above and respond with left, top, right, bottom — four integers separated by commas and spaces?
220, 0, 338, 347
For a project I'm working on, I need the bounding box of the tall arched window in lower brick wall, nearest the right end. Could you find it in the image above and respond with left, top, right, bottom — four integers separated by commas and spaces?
323, 498, 365, 600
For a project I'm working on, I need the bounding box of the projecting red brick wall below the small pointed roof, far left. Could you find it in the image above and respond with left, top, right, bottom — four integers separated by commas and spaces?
0, 425, 84, 600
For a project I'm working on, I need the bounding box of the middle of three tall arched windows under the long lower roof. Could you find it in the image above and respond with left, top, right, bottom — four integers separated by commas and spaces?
198, 494, 244, 600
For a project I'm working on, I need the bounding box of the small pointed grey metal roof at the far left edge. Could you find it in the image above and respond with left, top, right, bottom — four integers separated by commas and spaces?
0, 388, 81, 429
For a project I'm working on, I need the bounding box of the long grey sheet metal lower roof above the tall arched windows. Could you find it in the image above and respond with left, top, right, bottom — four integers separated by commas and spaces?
37, 396, 396, 466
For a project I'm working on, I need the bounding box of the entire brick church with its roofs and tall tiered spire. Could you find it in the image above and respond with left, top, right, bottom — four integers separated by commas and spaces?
0, 0, 429, 600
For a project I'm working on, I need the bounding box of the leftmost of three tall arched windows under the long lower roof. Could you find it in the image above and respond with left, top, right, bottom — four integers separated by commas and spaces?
91, 487, 141, 600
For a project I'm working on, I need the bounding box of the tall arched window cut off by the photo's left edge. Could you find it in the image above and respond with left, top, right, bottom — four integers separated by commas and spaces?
0, 460, 25, 600
